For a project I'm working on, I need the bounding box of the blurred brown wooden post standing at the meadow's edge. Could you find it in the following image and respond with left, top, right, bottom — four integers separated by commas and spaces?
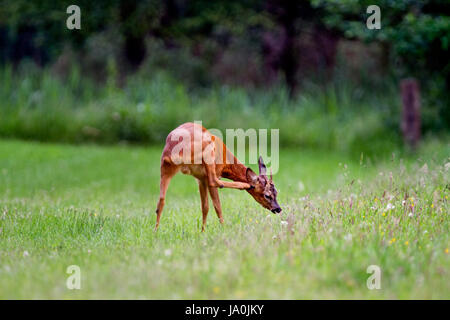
400, 78, 420, 149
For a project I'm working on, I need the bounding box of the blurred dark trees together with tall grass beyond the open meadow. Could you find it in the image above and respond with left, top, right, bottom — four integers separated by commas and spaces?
0, 0, 450, 154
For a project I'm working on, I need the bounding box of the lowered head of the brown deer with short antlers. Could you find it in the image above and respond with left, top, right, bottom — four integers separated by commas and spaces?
246, 156, 281, 213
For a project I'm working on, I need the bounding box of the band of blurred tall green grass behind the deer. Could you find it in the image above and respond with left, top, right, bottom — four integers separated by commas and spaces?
0, 64, 406, 154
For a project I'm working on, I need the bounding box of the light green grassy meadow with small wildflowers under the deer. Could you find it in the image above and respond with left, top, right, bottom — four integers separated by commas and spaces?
0, 140, 450, 299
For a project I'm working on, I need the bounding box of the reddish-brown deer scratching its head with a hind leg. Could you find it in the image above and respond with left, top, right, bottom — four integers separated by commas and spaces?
155, 122, 282, 232
